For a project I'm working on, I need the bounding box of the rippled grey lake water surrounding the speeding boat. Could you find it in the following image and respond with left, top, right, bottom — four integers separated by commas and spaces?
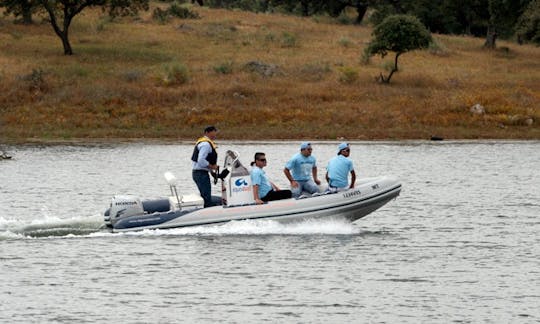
0, 141, 540, 323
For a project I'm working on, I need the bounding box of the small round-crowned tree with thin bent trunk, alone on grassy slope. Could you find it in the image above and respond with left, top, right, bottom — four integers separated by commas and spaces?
365, 15, 431, 83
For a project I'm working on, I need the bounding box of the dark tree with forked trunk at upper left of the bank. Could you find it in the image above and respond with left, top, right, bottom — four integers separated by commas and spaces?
38, 0, 148, 55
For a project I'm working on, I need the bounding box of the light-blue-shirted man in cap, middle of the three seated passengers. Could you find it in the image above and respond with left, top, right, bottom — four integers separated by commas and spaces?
283, 142, 321, 198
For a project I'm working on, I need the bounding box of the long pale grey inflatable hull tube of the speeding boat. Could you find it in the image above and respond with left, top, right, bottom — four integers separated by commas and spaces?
106, 177, 401, 232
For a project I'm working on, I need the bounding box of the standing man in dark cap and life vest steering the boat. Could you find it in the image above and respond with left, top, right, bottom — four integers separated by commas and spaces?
191, 126, 218, 208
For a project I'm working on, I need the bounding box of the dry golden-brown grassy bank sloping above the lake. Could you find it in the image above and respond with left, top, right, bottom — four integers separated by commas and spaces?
0, 5, 540, 142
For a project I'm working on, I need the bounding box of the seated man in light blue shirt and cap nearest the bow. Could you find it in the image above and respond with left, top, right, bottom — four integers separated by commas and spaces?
326, 143, 356, 191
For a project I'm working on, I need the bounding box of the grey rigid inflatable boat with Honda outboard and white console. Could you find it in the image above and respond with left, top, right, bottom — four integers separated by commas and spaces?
104, 151, 401, 232
